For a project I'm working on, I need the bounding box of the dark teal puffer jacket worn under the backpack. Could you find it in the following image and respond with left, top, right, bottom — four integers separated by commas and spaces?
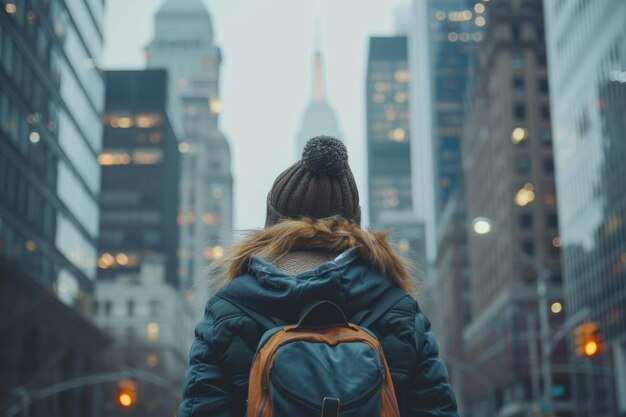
178, 250, 458, 417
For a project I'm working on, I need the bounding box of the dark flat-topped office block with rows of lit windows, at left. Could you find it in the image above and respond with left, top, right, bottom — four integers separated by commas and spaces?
98, 70, 180, 287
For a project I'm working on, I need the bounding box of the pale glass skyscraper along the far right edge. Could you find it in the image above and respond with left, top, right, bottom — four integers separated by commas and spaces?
545, 0, 626, 416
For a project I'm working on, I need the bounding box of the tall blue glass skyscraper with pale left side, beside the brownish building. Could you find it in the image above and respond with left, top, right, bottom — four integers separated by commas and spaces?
409, 0, 480, 384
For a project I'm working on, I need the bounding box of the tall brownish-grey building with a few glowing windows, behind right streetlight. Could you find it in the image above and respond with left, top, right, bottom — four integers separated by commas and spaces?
461, 0, 573, 416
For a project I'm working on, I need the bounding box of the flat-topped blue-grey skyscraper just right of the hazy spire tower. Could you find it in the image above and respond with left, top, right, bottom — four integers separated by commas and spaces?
365, 36, 425, 286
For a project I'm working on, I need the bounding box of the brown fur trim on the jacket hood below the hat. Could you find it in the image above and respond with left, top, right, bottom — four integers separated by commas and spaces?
219, 216, 415, 294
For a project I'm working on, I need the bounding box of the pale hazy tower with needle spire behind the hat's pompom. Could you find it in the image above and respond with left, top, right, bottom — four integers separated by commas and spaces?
295, 12, 342, 159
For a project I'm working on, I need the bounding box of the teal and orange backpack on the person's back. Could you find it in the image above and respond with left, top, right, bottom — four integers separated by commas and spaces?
217, 288, 408, 417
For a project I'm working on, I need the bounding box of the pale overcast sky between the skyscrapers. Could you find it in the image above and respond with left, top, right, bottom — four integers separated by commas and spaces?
103, 0, 407, 229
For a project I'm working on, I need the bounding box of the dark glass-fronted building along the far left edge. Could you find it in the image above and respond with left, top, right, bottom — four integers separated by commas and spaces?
0, 0, 106, 417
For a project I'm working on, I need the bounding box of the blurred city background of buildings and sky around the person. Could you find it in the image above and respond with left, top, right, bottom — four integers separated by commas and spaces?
0, 0, 626, 417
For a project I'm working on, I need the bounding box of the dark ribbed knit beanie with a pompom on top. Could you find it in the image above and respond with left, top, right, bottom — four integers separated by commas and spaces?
265, 136, 361, 227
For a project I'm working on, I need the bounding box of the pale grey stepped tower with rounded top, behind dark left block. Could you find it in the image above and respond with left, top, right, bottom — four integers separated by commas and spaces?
146, 0, 233, 314
